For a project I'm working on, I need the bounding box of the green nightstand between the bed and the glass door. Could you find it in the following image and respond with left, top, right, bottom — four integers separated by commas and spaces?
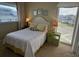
47, 32, 61, 46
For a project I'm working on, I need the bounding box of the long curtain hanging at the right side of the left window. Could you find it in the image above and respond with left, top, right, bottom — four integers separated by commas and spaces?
16, 2, 26, 29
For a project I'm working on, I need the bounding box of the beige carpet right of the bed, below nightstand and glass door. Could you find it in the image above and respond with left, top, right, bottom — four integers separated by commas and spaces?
36, 43, 74, 57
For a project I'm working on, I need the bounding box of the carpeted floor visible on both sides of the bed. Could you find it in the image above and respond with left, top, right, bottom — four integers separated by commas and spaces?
0, 43, 74, 57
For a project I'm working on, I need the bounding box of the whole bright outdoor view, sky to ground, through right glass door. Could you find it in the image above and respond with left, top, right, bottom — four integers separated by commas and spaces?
57, 7, 78, 44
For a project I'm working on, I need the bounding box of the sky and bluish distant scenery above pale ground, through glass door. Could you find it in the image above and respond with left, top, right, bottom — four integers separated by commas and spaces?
59, 7, 77, 25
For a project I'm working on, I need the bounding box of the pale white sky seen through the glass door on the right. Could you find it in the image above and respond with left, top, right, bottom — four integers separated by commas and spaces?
59, 7, 78, 15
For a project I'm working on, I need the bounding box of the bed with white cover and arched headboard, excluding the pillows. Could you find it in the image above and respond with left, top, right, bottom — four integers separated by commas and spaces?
4, 16, 48, 57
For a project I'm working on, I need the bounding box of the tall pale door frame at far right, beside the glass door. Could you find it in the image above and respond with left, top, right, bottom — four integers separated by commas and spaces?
72, 7, 79, 52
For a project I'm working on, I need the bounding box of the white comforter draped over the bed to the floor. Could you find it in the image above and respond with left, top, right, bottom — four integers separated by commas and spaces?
4, 28, 46, 57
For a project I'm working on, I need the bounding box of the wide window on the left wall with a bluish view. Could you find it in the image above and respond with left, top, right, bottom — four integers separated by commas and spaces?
0, 4, 18, 22
